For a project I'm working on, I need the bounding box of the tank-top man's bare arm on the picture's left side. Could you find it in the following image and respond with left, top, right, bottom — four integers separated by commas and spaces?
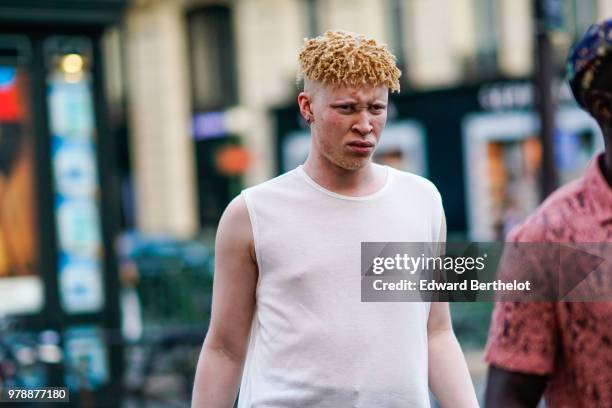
191, 196, 257, 408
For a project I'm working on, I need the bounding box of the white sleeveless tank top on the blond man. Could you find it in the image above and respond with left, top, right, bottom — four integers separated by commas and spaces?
238, 166, 445, 408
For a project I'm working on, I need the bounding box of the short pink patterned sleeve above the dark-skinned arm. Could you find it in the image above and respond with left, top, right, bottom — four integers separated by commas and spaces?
485, 223, 558, 375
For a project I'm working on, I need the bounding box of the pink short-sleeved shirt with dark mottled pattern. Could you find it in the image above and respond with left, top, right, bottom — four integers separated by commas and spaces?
485, 155, 612, 408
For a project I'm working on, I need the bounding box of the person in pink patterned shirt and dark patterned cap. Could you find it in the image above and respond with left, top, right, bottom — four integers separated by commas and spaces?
485, 20, 612, 407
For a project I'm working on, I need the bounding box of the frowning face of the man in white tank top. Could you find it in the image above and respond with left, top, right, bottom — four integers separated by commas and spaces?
311, 85, 388, 170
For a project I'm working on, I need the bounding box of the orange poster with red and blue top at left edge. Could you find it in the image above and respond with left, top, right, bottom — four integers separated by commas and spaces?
0, 63, 44, 315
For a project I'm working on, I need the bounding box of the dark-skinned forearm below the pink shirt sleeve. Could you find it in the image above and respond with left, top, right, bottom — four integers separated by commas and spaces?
485, 366, 548, 408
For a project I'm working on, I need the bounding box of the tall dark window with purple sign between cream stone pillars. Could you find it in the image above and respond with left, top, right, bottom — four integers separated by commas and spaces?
187, 6, 241, 227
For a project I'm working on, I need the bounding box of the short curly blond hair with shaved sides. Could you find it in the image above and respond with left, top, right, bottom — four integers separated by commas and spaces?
298, 30, 402, 92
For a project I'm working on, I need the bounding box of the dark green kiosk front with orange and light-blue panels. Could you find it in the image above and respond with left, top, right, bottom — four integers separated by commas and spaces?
0, 0, 126, 406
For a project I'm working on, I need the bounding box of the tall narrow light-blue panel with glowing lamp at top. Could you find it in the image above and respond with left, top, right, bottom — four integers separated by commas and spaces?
48, 38, 104, 313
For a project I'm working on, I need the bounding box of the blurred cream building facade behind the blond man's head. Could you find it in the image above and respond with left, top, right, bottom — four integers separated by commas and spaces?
107, 0, 612, 236
